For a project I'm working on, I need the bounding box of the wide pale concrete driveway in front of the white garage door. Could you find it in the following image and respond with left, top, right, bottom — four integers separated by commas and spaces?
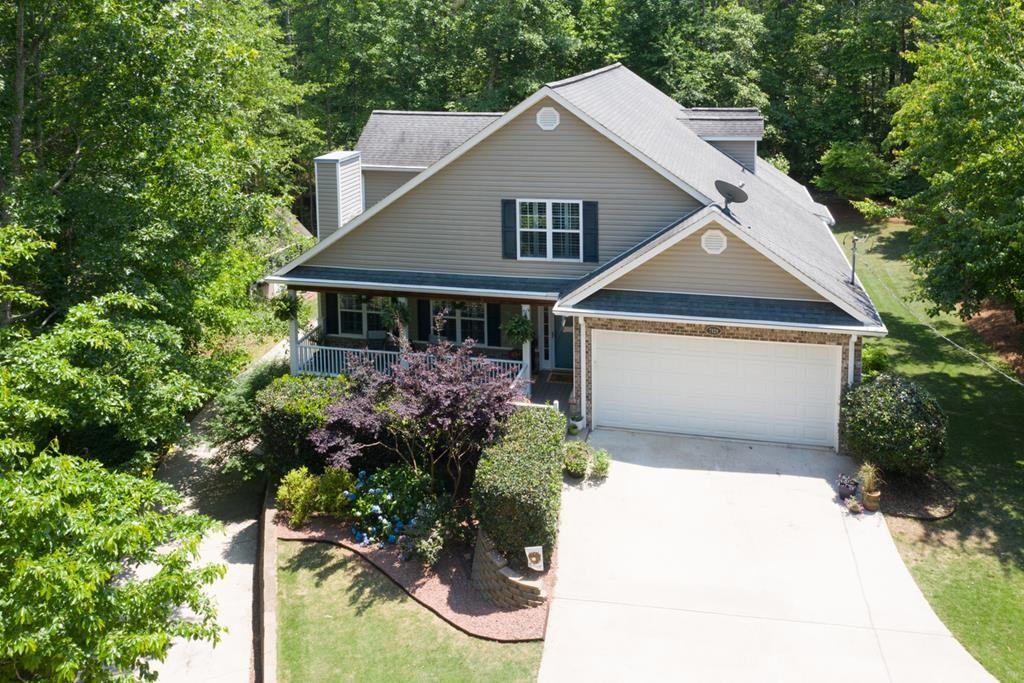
540, 430, 992, 683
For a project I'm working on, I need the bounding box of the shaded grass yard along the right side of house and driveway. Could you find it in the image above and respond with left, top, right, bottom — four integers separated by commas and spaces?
836, 205, 1024, 681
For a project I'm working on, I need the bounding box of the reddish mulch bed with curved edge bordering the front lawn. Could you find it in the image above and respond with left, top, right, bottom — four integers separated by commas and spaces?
274, 514, 554, 642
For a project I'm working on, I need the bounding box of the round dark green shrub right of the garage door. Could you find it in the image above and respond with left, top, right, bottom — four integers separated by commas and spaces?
842, 375, 946, 474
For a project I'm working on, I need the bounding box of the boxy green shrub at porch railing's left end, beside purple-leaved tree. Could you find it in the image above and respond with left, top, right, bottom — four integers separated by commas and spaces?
256, 375, 348, 472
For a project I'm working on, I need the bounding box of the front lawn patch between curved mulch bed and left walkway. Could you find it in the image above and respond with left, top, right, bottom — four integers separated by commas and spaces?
278, 542, 542, 683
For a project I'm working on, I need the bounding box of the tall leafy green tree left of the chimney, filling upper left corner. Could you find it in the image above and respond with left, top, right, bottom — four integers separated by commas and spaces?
0, 0, 313, 462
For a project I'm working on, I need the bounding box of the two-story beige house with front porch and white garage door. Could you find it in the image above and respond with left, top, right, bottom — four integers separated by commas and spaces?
269, 63, 886, 447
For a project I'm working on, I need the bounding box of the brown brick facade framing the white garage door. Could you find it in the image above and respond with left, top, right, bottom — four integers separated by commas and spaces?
572, 317, 862, 427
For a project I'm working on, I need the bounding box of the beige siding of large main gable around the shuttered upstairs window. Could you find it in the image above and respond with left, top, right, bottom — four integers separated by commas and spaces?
308, 100, 699, 278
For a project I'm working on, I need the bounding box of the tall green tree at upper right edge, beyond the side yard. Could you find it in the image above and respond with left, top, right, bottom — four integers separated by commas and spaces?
892, 0, 1024, 322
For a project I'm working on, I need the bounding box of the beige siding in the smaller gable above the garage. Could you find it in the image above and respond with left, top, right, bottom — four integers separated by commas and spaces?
607, 227, 824, 301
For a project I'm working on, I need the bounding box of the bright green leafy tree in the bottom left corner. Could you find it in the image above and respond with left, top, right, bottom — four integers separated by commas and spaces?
0, 447, 223, 683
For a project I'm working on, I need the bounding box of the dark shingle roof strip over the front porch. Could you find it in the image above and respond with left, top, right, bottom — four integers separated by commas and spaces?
282, 265, 573, 299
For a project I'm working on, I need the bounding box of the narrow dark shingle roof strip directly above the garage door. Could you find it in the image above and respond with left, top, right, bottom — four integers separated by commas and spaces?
573, 290, 864, 328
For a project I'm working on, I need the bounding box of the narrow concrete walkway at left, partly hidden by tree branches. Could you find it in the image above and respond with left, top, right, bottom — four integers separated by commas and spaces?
156, 342, 287, 683
